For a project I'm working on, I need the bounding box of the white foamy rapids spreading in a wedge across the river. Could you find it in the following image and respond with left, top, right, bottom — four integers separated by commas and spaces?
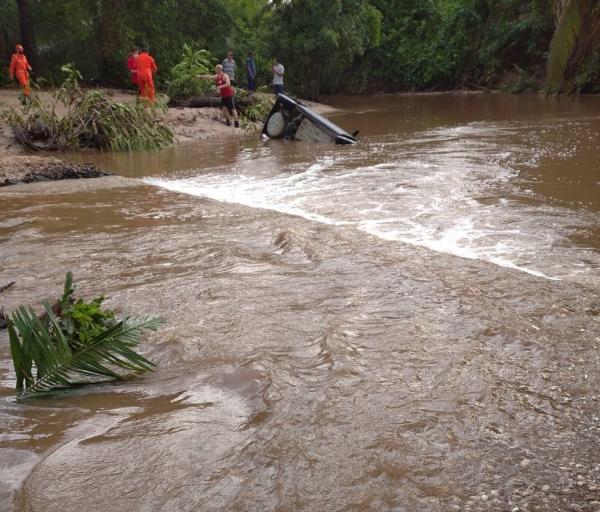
145, 123, 590, 280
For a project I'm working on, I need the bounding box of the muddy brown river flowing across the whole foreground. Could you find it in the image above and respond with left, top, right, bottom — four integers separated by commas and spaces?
0, 94, 600, 512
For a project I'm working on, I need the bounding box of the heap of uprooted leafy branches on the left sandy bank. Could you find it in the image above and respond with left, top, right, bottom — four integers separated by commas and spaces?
2, 66, 173, 151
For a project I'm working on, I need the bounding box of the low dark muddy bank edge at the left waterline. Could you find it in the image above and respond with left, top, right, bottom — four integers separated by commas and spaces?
0, 155, 110, 187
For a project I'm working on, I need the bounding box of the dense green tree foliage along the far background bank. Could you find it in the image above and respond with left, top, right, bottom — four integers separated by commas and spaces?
0, 0, 600, 97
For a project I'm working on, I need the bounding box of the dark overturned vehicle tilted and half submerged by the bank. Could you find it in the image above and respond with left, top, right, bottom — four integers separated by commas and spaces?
262, 94, 358, 144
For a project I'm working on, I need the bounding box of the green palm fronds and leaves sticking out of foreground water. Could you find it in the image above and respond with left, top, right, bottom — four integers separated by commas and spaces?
8, 272, 164, 398
